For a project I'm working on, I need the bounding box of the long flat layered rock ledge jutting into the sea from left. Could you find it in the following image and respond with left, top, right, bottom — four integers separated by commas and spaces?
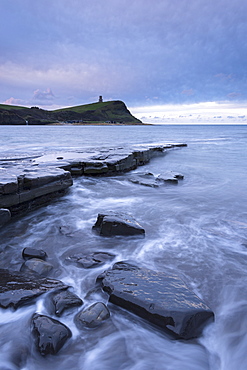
0, 144, 186, 226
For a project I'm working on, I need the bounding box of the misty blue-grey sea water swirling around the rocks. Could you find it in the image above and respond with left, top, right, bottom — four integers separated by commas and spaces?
0, 125, 247, 370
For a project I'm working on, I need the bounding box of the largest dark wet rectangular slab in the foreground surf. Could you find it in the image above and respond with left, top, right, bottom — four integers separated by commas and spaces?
99, 262, 214, 339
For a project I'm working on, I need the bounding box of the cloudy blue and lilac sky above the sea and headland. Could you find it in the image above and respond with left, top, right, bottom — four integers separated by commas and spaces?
0, 0, 247, 123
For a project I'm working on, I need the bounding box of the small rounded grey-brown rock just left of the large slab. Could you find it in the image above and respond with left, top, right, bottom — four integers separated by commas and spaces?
74, 302, 110, 329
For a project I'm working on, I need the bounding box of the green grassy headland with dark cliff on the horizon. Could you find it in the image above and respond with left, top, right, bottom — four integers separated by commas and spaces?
0, 100, 142, 125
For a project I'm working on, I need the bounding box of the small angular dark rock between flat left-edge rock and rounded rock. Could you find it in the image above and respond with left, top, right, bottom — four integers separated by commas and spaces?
49, 287, 83, 316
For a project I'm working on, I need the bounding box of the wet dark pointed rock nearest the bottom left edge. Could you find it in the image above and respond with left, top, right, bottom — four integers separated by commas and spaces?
32, 314, 72, 356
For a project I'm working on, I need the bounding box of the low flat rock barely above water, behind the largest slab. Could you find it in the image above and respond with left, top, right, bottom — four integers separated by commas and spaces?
66, 252, 115, 268
